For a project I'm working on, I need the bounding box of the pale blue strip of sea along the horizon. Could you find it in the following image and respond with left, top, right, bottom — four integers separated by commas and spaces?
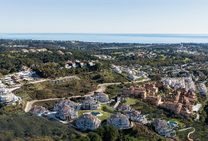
0, 33, 208, 43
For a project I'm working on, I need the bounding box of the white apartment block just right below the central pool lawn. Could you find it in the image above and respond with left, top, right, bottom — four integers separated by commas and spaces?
107, 113, 131, 130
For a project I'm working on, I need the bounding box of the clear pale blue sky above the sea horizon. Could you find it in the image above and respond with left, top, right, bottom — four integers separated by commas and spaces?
0, 0, 208, 34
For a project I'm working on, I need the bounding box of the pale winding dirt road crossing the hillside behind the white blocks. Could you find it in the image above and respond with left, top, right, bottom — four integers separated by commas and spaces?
25, 78, 151, 112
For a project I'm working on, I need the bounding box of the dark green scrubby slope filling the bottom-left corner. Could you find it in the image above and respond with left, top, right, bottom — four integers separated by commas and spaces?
0, 114, 76, 141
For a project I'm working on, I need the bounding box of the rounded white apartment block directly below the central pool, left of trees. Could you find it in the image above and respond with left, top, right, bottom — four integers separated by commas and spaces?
76, 114, 101, 130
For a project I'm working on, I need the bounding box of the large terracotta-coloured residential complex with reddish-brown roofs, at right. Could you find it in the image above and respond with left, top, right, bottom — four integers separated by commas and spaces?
120, 81, 197, 117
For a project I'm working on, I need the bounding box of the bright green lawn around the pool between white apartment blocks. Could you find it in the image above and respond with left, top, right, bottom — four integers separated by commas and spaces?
78, 104, 114, 121
